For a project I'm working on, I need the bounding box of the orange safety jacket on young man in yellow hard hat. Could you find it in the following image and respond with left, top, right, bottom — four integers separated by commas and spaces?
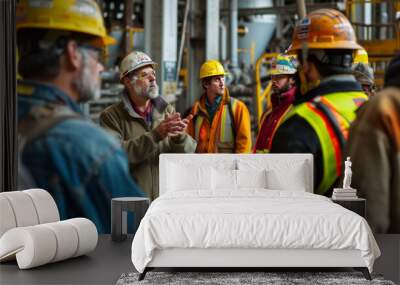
187, 88, 251, 153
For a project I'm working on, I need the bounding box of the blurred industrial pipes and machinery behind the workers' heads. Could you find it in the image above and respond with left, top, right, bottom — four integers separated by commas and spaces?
80, 0, 400, 131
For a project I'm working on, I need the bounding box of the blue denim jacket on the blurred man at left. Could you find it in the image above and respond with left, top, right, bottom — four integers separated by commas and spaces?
18, 81, 144, 233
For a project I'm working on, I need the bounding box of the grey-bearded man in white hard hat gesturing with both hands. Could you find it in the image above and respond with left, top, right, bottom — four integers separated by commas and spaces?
100, 51, 196, 199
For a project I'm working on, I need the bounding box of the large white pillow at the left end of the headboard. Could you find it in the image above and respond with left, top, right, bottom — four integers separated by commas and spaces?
167, 163, 212, 191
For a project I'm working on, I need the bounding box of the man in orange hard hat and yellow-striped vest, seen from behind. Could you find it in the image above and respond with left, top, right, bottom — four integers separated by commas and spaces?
271, 9, 368, 195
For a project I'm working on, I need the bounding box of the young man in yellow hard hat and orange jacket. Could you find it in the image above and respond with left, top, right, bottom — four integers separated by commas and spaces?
188, 60, 251, 153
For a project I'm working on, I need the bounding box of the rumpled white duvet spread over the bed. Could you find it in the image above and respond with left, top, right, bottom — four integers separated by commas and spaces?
132, 189, 380, 272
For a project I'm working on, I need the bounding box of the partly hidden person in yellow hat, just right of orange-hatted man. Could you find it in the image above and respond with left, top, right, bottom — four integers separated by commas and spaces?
352, 49, 375, 97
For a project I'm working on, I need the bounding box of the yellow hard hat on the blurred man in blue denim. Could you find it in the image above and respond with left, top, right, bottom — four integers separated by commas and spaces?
16, 0, 116, 46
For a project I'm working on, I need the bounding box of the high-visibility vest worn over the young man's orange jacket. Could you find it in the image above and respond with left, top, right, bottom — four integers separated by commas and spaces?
193, 97, 238, 153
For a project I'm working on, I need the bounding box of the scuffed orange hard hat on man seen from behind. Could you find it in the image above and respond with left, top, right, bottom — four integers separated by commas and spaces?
288, 9, 362, 53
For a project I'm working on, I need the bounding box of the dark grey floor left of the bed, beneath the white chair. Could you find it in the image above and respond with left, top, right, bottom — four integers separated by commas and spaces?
0, 235, 135, 285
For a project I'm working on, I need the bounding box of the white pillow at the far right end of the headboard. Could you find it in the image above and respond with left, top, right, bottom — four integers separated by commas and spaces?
266, 167, 307, 192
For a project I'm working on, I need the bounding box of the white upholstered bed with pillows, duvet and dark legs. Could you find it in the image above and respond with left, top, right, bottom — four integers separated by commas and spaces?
132, 154, 380, 278
